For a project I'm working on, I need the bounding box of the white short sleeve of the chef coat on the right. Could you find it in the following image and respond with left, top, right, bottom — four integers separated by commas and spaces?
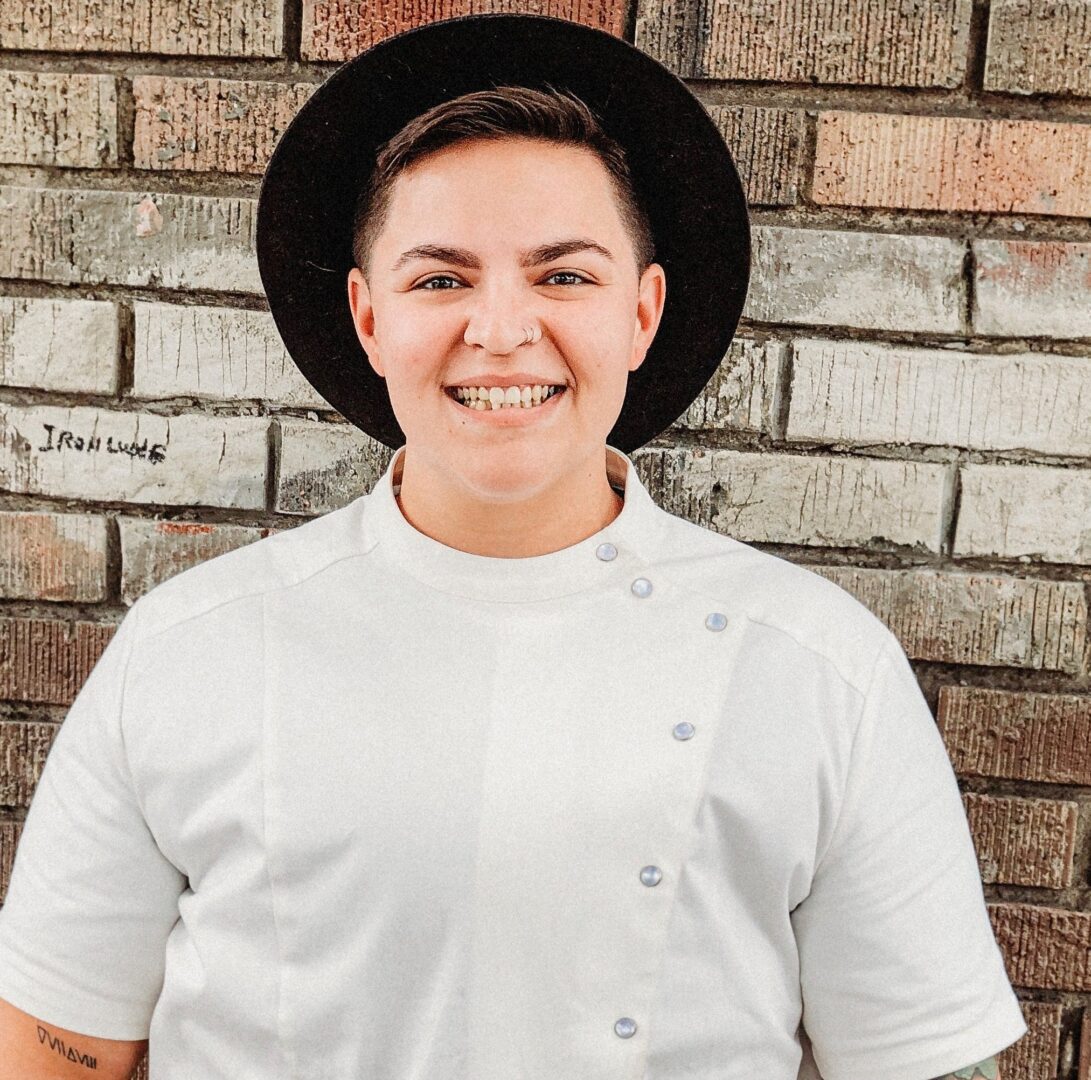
791, 635, 1027, 1080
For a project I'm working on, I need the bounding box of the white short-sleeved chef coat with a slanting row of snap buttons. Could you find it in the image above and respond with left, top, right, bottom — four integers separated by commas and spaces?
0, 447, 1027, 1080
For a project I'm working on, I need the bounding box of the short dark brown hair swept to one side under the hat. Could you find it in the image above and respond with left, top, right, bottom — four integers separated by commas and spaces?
352, 84, 656, 278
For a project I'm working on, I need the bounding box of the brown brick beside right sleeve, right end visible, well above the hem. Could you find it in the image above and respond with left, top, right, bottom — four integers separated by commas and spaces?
962, 792, 1080, 889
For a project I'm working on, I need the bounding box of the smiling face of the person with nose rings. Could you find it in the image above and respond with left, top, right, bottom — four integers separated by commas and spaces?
348, 137, 666, 500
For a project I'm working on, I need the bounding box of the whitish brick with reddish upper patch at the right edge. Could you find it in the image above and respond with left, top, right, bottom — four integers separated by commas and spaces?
973, 240, 1091, 338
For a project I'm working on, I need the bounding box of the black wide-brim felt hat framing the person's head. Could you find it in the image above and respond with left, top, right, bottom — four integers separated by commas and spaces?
256, 13, 751, 454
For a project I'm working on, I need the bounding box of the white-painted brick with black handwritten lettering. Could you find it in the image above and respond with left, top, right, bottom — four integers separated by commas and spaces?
0, 405, 268, 509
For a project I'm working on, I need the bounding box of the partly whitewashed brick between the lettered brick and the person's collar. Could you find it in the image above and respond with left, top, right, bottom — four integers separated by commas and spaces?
273, 417, 393, 515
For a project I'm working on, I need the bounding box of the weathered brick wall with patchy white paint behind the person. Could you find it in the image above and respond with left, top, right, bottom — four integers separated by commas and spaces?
0, 0, 1091, 1080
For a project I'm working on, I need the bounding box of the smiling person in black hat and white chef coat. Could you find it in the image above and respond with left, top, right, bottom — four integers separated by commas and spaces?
0, 14, 1027, 1080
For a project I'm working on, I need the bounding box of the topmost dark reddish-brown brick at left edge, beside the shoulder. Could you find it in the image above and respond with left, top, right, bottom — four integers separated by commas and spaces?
0, 619, 117, 705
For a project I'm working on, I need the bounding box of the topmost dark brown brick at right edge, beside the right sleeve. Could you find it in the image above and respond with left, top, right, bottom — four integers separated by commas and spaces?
936, 686, 1091, 785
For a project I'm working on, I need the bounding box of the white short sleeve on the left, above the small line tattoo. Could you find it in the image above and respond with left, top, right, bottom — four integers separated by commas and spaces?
0, 600, 187, 1040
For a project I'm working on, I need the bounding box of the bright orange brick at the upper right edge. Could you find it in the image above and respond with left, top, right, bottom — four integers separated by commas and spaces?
814, 112, 1091, 217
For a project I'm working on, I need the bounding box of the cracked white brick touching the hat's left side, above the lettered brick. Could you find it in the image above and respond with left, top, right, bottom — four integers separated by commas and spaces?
133, 301, 322, 409
